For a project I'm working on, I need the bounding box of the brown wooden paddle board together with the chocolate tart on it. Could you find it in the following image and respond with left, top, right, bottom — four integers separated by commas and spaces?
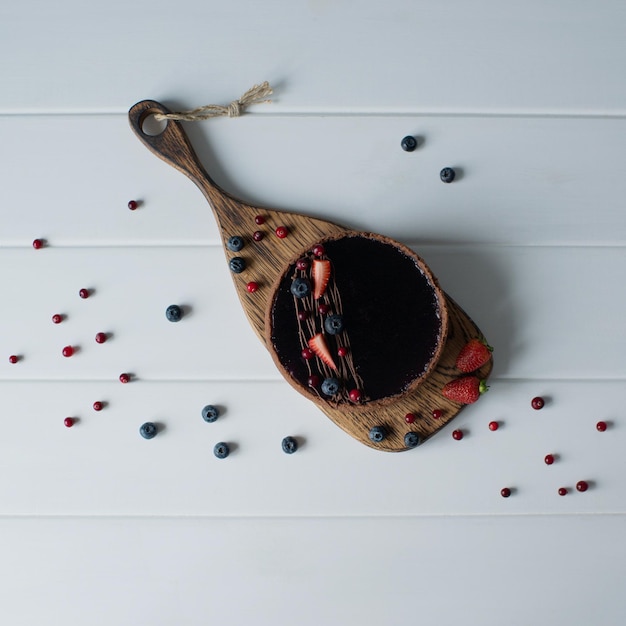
129, 100, 492, 452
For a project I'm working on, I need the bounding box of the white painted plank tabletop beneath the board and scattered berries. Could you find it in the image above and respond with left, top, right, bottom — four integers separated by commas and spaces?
0, 0, 626, 626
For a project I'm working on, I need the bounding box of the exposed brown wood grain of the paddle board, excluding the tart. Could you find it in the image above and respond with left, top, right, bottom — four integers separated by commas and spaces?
129, 100, 492, 452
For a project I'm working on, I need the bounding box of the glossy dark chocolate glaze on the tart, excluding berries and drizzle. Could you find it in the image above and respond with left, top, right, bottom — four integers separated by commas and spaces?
270, 235, 442, 401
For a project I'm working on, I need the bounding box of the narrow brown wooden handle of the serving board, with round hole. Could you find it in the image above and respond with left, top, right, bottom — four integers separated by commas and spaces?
128, 100, 219, 199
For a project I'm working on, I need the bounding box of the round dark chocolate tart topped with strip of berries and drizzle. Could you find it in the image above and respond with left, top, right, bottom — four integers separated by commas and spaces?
266, 232, 447, 406
